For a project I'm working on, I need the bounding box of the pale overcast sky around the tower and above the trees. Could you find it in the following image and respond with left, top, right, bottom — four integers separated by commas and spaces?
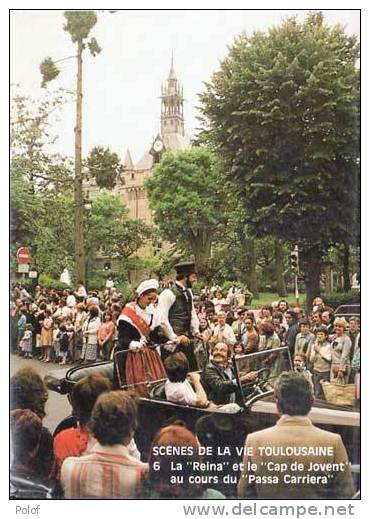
10, 10, 360, 165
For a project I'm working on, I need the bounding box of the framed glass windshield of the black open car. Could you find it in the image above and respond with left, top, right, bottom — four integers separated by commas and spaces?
233, 347, 292, 400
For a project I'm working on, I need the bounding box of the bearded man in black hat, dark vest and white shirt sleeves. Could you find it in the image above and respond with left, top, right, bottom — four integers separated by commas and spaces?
157, 261, 202, 371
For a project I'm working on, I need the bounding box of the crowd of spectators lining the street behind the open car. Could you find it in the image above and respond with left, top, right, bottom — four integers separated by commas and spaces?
11, 284, 360, 398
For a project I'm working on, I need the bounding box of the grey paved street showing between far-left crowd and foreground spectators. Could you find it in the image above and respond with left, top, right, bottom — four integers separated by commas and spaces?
10, 354, 71, 433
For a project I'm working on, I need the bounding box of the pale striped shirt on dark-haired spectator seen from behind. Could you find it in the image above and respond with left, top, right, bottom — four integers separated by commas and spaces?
61, 443, 148, 499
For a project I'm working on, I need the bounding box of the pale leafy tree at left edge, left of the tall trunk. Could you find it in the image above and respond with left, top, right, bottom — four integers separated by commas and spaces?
10, 90, 73, 277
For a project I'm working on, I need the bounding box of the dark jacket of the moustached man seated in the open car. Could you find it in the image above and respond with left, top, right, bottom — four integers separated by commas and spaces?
201, 361, 237, 404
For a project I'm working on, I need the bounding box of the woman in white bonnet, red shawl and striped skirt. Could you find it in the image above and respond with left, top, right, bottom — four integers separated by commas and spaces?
114, 279, 166, 396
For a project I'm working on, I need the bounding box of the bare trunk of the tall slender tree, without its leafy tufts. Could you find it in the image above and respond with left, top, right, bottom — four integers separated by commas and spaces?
74, 40, 86, 285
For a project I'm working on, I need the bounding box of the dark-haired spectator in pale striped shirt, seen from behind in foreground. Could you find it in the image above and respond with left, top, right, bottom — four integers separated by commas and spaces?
61, 391, 148, 499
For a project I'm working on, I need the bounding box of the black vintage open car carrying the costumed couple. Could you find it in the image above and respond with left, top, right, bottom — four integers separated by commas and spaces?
46, 347, 360, 484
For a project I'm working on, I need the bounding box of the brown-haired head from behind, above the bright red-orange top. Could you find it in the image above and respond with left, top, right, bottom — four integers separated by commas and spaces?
72, 373, 111, 427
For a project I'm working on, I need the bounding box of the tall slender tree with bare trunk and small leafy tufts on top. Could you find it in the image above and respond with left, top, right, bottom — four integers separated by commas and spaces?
40, 11, 101, 283
